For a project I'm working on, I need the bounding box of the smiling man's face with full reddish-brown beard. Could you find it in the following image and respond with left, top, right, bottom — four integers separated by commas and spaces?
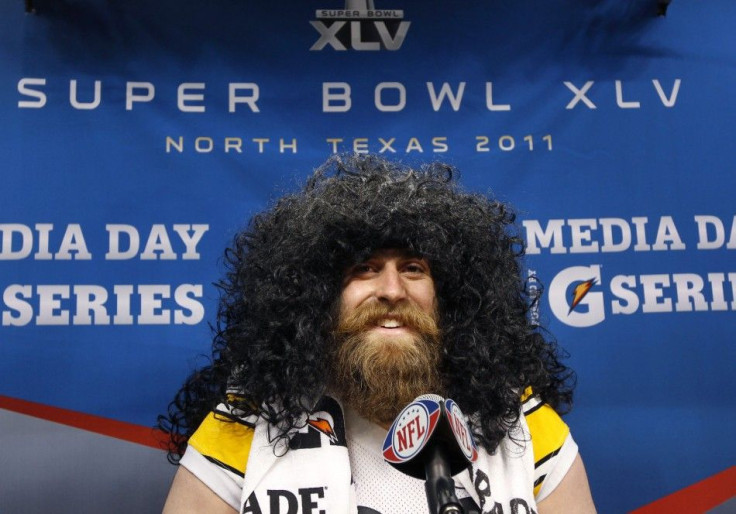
333, 249, 442, 426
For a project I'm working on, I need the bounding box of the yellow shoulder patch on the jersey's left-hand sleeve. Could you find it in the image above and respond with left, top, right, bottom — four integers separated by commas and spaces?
189, 412, 253, 476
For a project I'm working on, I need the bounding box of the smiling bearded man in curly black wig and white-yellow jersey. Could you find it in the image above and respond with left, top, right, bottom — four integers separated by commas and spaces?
161, 156, 595, 514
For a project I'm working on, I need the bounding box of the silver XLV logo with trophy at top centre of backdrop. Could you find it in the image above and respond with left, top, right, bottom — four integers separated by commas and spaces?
309, 0, 411, 51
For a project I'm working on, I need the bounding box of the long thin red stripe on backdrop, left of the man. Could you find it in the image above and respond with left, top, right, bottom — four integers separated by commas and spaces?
0, 395, 167, 450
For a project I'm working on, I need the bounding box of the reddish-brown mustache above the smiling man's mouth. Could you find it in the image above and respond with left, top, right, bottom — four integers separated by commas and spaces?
335, 302, 440, 337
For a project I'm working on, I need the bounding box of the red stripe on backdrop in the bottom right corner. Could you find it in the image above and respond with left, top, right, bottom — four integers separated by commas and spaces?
631, 466, 736, 514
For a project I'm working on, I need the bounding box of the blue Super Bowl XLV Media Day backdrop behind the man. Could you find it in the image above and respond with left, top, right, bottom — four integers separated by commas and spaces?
0, 0, 736, 512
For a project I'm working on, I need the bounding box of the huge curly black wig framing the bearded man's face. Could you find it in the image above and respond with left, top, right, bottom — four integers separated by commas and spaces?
159, 155, 574, 462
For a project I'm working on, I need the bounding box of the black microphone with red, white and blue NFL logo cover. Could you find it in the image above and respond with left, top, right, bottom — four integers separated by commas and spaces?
383, 394, 478, 514
